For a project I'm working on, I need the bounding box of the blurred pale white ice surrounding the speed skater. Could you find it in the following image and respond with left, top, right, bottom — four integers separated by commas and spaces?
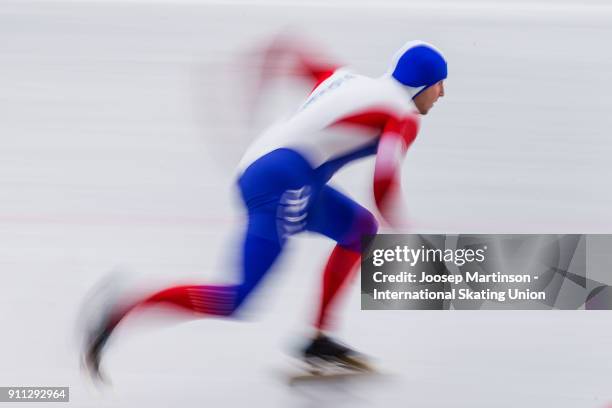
0, 0, 612, 408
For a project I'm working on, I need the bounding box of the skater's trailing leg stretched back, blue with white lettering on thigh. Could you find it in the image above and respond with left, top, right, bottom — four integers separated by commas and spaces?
85, 149, 312, 380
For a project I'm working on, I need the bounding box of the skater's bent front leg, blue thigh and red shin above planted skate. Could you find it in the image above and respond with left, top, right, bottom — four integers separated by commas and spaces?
307, 186, 378, 330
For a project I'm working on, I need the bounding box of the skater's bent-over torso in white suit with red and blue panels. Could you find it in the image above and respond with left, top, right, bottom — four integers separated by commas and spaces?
239, 68, 418, 177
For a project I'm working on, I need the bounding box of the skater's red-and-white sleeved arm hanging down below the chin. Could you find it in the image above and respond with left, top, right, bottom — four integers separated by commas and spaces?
374, 115, 419, 227
